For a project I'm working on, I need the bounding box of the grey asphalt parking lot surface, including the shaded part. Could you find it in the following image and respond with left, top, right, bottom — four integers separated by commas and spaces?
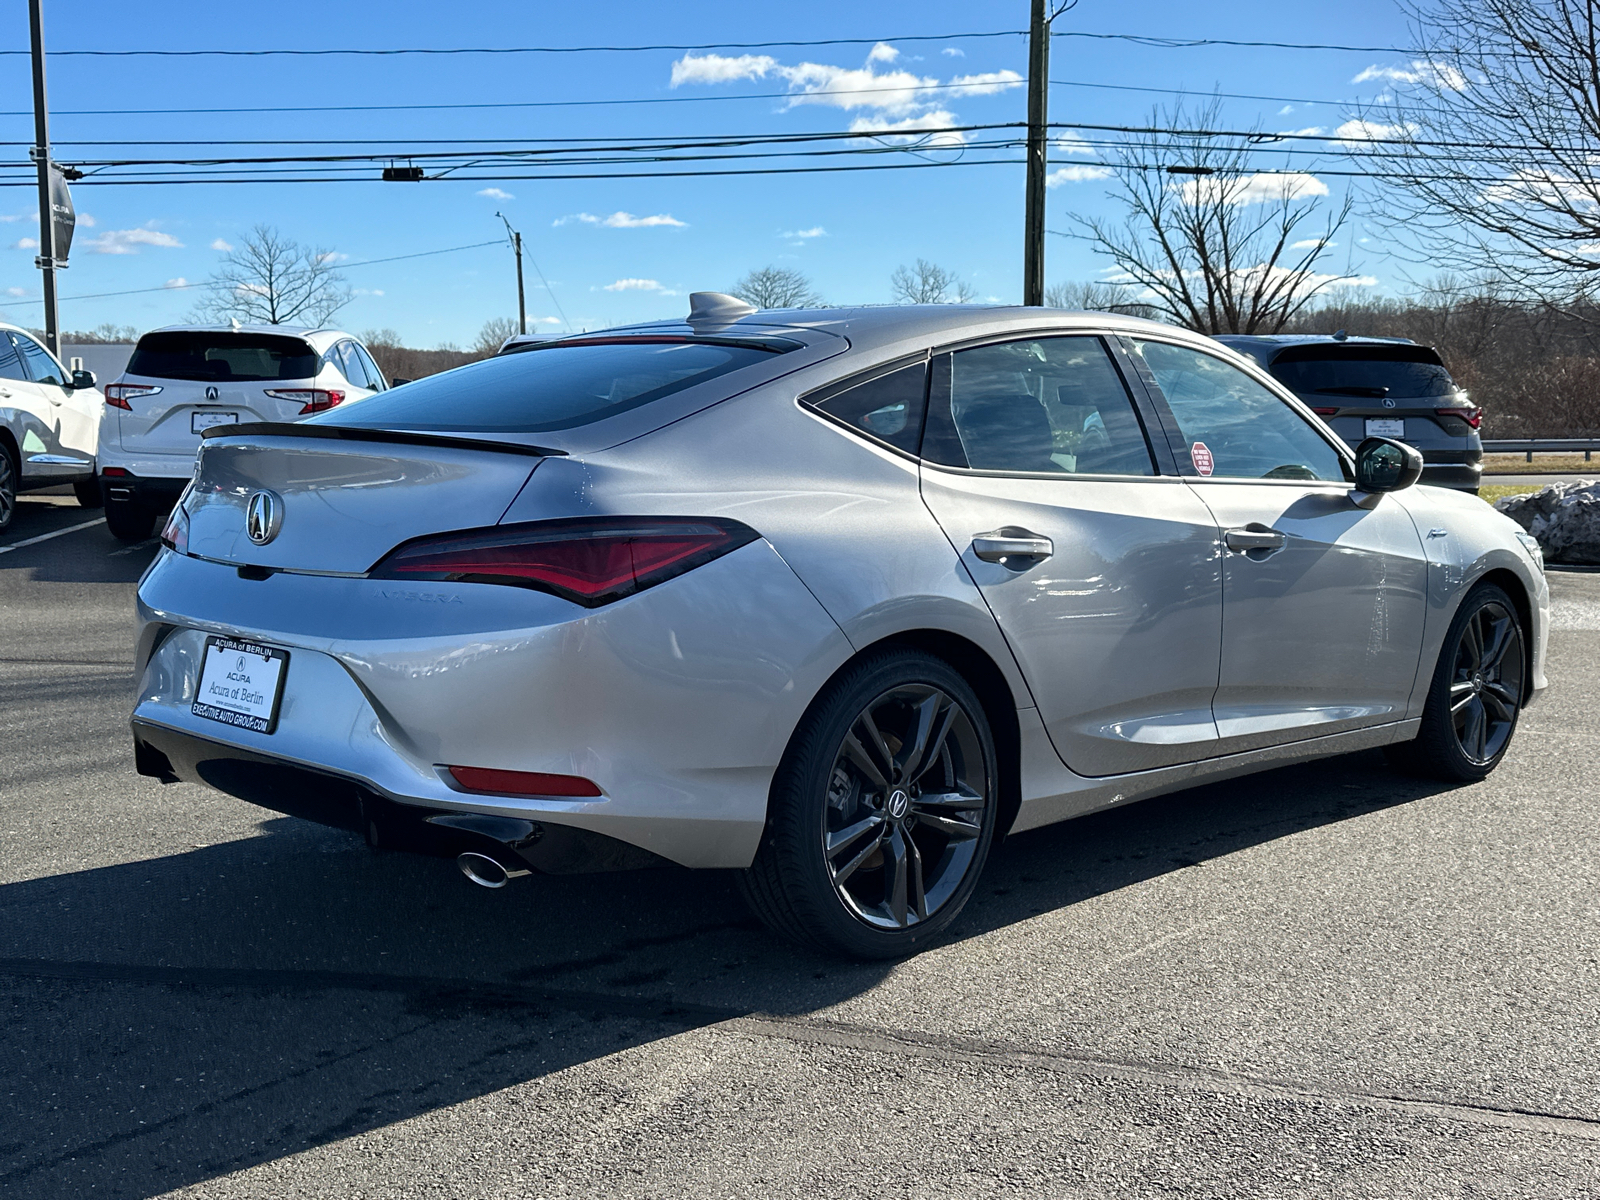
0, 483, 1600, 1200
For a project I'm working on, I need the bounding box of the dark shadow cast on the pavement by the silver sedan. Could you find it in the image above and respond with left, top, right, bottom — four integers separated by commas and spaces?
0, 754, 1443, 1200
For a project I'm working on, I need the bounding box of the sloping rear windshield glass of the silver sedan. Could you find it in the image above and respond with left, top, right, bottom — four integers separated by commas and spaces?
312, 341, 784, 434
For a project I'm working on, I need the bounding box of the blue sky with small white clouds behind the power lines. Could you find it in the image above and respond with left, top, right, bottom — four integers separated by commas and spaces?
0, 0, 1410, 346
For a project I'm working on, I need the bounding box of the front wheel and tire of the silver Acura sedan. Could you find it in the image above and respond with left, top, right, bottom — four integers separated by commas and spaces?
1386, 584, 1528, 782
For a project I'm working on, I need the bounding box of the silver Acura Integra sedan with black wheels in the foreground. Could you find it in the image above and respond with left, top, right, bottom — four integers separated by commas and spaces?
133, 293, 1549, 957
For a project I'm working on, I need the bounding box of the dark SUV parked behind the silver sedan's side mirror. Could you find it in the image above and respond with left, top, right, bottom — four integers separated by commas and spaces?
1218, 333, 1483, 494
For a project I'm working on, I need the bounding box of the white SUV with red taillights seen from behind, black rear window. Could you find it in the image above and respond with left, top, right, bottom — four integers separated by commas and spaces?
99, 325, 389, 542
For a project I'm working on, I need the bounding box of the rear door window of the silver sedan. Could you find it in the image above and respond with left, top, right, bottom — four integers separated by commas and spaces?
922, 336, 1155, 475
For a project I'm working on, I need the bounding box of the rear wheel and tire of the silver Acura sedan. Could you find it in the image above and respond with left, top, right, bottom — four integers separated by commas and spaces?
739, 650, 1000, 958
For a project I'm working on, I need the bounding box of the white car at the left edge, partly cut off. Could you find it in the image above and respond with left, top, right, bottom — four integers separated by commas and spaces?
0, 323, 101, 530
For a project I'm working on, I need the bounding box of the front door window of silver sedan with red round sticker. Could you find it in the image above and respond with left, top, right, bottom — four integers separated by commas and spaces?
1134, 341, 1344, 483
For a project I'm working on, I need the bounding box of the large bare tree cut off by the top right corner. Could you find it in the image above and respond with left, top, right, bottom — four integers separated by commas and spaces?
1363, 0, 1600, 299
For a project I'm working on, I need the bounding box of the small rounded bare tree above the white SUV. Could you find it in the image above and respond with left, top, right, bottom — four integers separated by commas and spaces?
197, 226, 352, 325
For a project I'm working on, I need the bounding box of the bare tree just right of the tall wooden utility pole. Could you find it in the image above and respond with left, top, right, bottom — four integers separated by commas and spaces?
1072, 101, 1350, 333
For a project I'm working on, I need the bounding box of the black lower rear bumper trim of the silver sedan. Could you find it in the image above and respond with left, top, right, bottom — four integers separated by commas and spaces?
133, 720, 666, 875
